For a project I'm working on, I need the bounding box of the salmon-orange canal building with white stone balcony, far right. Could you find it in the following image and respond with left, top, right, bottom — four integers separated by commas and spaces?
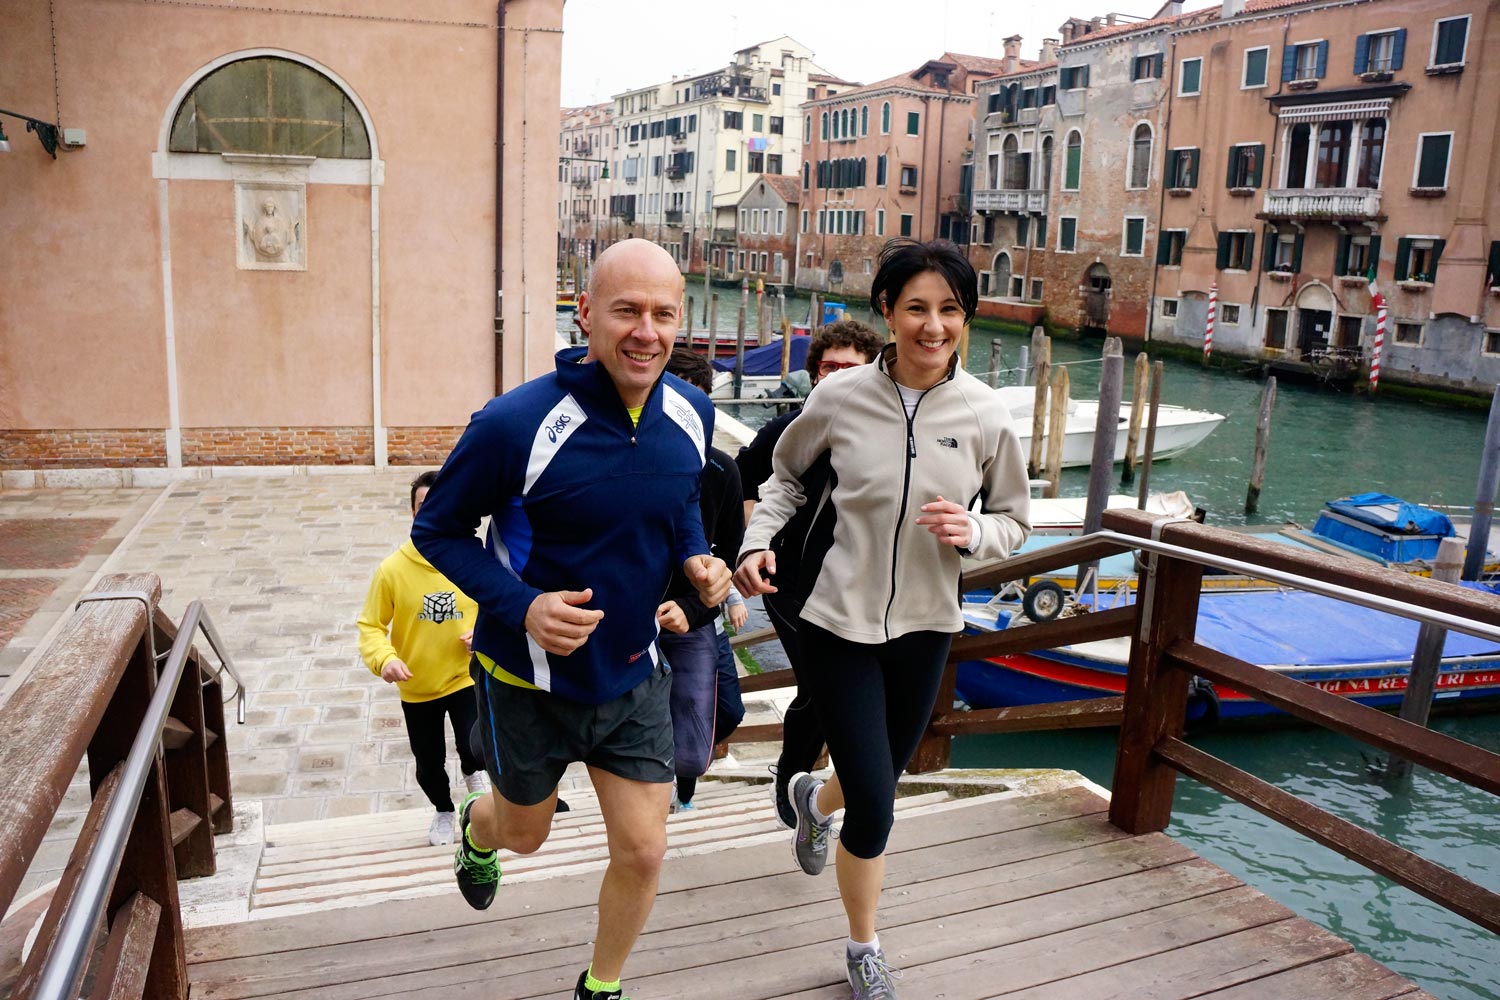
1152, 0, 1500, 387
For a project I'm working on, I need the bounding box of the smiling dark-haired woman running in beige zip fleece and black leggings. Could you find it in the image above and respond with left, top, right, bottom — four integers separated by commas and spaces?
735, 240, 1031, 1000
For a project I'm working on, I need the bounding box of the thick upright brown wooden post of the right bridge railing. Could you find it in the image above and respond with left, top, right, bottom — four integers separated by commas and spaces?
1110, 556, 1203, 834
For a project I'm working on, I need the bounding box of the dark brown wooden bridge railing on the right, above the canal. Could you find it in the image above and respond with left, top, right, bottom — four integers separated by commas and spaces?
732, 510, 1500, 933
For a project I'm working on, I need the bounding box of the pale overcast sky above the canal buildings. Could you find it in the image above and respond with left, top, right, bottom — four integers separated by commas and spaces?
563, 0, 1170, 108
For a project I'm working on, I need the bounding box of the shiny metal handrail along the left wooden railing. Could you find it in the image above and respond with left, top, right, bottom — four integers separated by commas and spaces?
32, 595, 217, 1000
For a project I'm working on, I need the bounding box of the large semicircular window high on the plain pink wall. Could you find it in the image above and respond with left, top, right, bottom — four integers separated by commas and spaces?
167, 55, 371, 159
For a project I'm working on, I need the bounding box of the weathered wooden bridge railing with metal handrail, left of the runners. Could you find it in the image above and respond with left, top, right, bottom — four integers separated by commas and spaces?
0, 574, 243, 1000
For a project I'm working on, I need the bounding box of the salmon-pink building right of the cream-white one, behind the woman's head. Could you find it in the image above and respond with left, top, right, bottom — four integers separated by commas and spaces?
797, 52, 1004, 295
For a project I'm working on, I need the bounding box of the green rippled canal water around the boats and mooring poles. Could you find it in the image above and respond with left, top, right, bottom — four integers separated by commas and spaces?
558, 285, 1500, 1000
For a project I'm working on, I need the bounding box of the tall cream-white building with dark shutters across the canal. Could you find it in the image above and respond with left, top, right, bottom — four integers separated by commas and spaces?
611, 36, 854, 271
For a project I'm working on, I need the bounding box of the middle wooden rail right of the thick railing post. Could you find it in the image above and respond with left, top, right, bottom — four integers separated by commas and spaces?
1167, 642, 1500, 795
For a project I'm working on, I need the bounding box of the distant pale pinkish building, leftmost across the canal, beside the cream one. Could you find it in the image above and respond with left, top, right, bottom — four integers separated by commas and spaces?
558, 102, 615, 261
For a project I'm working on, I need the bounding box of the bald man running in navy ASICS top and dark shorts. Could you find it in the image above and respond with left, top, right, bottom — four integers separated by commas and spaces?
411, 240, 729, 1000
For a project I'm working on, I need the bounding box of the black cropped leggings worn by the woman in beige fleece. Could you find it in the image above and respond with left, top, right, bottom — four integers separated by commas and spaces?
798, 619, 953, 858
